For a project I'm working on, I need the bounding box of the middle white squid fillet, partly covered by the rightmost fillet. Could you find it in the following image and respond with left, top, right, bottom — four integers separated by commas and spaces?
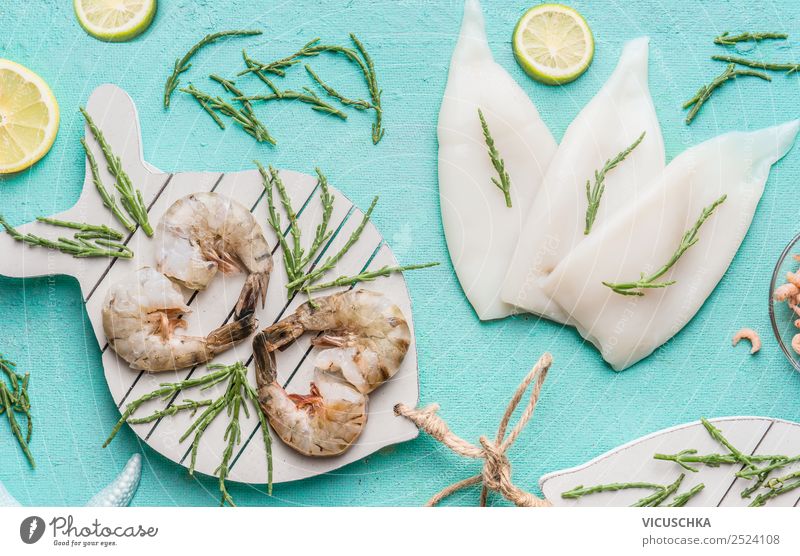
501, 37, 664, 323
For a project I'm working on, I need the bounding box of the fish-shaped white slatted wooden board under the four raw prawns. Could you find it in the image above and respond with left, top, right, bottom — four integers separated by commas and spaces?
0, 85, 419, 484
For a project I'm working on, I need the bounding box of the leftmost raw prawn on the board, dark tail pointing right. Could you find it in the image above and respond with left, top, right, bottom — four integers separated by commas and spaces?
103, 267, 258, 372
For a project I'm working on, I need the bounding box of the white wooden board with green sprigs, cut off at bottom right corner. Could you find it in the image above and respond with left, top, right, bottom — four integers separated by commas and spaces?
539, 417, 800, 507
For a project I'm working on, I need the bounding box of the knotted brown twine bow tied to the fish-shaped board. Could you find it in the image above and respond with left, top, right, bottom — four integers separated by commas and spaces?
394, 353, 553, 507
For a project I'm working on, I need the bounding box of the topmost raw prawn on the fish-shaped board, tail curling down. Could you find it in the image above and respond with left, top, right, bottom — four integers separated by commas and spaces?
156, 192, 273, 318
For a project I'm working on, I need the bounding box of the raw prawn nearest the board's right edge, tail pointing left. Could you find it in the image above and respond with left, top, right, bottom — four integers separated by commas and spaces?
261, 290, 411, 394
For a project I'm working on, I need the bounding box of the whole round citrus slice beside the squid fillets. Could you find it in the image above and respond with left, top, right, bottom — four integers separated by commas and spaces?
513, 4, 594, 85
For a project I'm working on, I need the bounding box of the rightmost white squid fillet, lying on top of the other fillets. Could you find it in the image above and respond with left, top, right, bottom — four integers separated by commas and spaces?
542, 124, 800, 371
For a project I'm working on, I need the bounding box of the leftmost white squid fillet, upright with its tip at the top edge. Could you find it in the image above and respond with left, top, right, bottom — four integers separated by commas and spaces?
438, 0, 556, 320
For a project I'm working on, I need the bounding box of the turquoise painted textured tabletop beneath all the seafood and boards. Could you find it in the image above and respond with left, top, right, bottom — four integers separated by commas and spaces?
0, 0, 800, 505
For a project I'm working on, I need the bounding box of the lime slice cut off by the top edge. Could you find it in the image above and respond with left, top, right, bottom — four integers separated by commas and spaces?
73, 0, 156, 42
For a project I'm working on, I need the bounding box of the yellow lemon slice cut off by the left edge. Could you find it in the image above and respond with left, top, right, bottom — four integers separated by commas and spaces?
0, 58, 58, 174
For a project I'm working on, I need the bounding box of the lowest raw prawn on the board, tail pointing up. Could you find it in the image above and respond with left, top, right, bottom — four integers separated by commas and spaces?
253, 334, 367, 456
